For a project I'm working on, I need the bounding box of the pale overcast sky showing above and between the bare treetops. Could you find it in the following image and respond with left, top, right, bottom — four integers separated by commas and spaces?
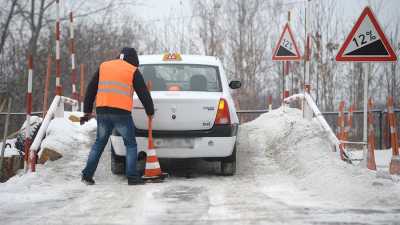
61, 0, 400, 48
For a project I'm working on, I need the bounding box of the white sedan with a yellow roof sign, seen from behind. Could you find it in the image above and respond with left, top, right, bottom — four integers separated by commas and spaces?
111, 53, 241, 175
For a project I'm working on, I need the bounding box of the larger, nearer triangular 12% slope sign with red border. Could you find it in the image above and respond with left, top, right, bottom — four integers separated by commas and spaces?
336, 7, 397, 62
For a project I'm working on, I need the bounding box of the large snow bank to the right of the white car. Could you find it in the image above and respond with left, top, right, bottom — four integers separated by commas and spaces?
240, 108, 400, 207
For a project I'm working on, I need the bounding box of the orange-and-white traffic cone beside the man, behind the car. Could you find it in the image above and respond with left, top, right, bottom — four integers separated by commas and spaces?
142, 117, 168, 182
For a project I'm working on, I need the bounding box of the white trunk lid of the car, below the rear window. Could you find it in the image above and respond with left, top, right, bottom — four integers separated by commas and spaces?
132, 91, 222, 131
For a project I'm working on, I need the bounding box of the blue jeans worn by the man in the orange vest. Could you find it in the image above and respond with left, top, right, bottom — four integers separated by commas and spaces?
82, 114, 138, 178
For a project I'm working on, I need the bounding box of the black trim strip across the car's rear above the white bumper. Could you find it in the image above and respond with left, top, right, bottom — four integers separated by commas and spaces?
113, 124, 239, 138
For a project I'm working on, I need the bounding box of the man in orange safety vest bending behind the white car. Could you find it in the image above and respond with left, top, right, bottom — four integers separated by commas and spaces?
81, 48, 154, 185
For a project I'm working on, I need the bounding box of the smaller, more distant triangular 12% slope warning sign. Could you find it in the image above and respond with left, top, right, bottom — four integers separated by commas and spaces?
272, 23, 301, 61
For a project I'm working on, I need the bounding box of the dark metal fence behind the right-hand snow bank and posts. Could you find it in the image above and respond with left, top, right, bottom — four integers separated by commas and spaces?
237, 109, 400, 149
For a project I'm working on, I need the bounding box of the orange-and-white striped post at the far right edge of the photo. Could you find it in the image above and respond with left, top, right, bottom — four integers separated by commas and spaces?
387, 96, 400, 174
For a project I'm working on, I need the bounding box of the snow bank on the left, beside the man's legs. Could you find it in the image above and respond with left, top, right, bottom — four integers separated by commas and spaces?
0, 112, 96, 209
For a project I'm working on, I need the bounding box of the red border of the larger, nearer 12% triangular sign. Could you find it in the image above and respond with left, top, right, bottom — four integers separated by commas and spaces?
336, 6, 397, 62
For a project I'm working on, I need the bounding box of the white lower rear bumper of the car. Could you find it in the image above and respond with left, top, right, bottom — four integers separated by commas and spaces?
111, 135, 236, 158
